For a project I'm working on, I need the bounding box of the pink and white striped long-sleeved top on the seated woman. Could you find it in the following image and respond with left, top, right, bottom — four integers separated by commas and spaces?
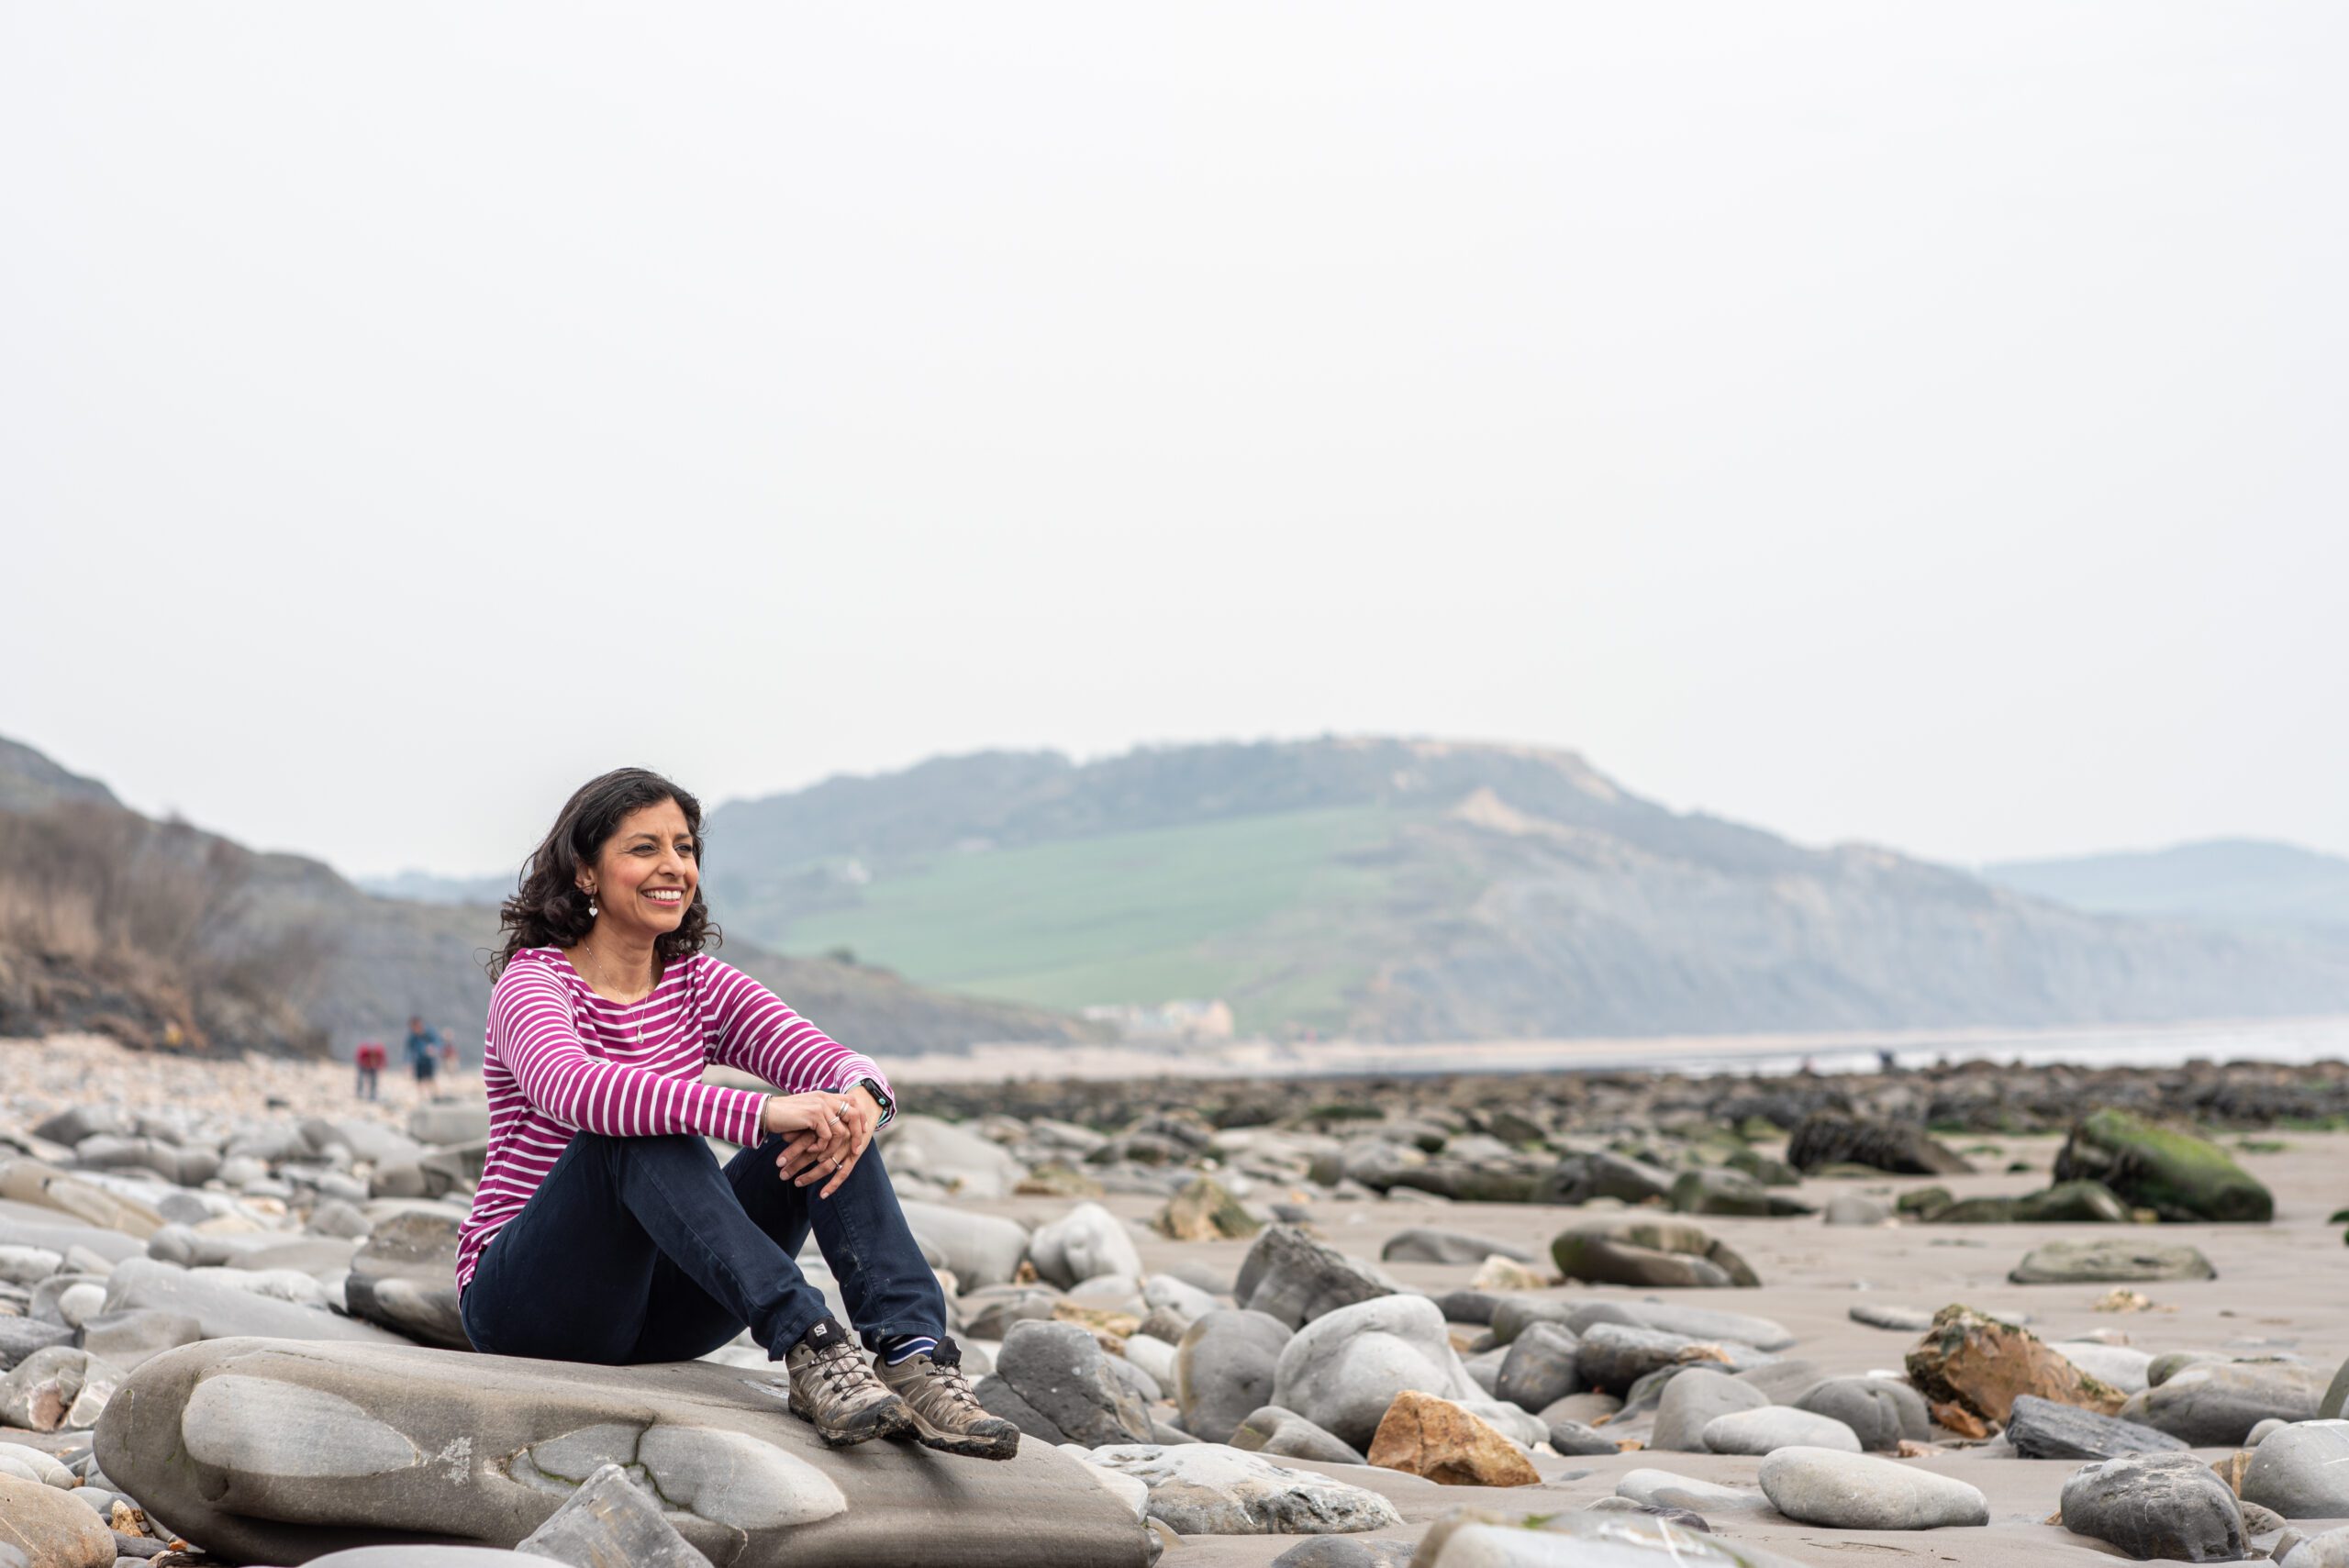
456, 949, 888, 1291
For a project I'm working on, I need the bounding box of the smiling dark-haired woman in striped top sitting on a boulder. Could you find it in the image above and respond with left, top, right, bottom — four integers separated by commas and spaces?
456, 768, 1019, 1460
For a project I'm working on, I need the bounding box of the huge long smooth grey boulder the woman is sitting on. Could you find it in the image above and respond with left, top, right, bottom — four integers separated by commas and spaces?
96, 1340, 1156, 1568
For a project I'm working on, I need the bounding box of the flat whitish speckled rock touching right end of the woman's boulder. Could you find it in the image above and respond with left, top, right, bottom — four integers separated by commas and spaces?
1090, 1443, 1402, 1535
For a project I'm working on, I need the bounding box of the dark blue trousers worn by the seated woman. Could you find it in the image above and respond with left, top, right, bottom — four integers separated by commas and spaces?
462, 1131, 947, 1366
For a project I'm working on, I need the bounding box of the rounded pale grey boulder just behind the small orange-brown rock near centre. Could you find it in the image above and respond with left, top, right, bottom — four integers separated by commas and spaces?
1268, 1296, 1484, 1453
